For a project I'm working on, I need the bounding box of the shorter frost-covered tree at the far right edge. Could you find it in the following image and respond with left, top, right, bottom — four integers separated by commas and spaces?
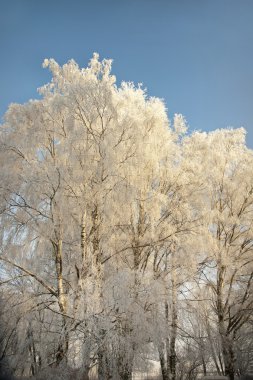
186, 129, 253, 379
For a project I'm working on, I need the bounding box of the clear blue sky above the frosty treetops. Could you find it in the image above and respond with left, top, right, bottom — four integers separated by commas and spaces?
0, 0, 253, 148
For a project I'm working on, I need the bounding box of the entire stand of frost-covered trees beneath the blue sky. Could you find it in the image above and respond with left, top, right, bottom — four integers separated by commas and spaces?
0, 53, 253, 380
